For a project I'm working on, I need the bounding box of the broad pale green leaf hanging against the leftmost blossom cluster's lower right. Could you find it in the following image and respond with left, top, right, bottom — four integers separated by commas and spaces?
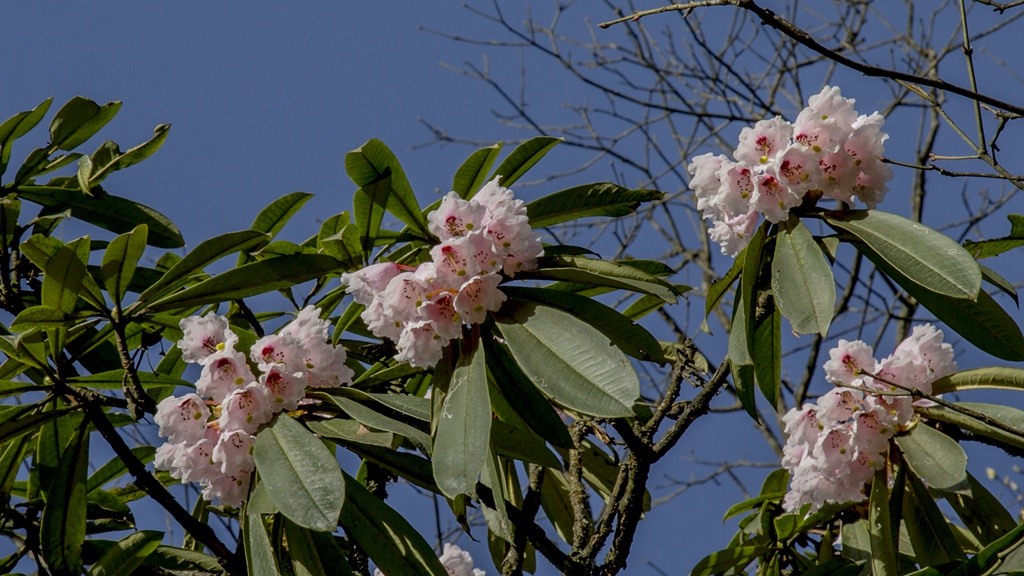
253, 413, 345, 532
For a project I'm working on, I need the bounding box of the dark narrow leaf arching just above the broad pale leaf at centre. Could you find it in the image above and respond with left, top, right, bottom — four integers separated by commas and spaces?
502, 286, 668, 365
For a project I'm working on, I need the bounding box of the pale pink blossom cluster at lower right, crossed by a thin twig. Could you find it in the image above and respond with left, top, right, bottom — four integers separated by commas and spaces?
782, 324, 956, 511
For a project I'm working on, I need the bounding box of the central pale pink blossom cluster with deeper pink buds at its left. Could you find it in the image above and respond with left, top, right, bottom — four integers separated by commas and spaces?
341, 176, 544, 368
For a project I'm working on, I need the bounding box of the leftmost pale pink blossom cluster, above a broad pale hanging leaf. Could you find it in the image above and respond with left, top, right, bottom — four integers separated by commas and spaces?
155, 306, 353, 506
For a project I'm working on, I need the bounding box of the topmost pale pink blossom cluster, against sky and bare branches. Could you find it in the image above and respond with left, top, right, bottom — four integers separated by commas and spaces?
686, 86, 892, 256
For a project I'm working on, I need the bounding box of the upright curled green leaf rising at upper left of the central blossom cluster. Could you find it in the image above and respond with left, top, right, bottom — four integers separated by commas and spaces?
345, 138, 425, 238
